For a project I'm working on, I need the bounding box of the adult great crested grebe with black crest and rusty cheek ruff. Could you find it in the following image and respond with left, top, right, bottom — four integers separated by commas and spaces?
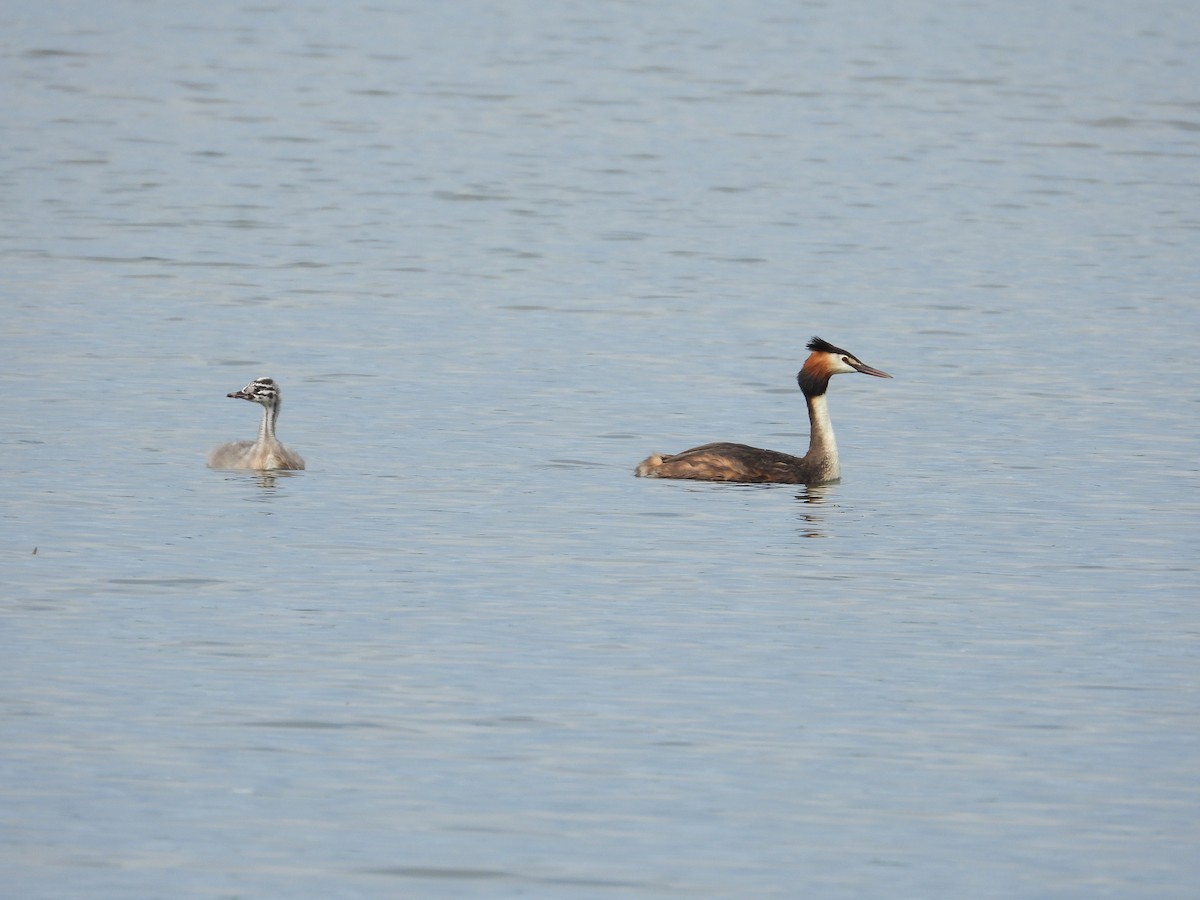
635, 337, 892, 485
